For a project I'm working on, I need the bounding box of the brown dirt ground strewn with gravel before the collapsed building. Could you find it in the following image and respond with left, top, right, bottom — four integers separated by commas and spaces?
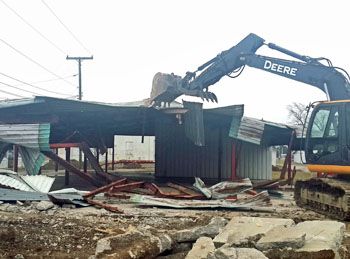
0, 167, 350, 259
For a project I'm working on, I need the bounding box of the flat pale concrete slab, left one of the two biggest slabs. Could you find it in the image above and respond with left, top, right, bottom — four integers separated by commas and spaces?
214, 217, 295, 247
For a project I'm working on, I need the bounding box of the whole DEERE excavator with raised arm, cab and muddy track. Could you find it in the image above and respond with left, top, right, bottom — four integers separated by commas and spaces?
150, 33, 350, 220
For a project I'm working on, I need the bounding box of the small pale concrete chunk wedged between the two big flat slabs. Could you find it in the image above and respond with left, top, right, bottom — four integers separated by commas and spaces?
256, 226, 306, 251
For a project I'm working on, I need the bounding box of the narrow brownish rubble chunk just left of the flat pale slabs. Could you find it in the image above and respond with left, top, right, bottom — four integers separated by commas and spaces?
170, 217, 227, 243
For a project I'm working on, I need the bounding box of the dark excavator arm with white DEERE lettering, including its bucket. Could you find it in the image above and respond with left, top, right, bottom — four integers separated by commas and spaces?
151, 33, 350, 105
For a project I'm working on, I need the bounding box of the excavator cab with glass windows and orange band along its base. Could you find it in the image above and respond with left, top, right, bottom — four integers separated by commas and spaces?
305, 101, 350, 174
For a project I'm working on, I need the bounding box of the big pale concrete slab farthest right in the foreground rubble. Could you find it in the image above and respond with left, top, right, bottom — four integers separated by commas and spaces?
257, 220, 345, 259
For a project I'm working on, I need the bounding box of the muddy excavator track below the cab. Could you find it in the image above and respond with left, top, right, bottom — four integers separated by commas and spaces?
294, 178, 350, 220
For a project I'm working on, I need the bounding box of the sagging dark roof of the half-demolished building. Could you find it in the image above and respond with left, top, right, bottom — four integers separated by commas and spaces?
0, 96, 293, 147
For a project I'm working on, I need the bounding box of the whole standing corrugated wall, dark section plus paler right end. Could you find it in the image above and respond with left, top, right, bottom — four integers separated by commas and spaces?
155, 124, 272, 181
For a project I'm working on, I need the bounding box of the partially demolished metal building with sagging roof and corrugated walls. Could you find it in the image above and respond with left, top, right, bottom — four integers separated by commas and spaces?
0, 97, 293, 185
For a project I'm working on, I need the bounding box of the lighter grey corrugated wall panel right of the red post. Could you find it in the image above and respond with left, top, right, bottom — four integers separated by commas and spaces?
237, 142, 272, 180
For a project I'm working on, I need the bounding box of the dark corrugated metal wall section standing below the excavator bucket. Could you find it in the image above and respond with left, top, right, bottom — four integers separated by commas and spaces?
155, 124, 232, 180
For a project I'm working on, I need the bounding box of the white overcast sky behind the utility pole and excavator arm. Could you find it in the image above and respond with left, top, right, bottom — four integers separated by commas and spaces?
0, 0, 350, 122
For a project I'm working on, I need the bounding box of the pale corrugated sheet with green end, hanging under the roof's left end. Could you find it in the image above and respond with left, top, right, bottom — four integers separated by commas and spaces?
0, 124, 50, 151
